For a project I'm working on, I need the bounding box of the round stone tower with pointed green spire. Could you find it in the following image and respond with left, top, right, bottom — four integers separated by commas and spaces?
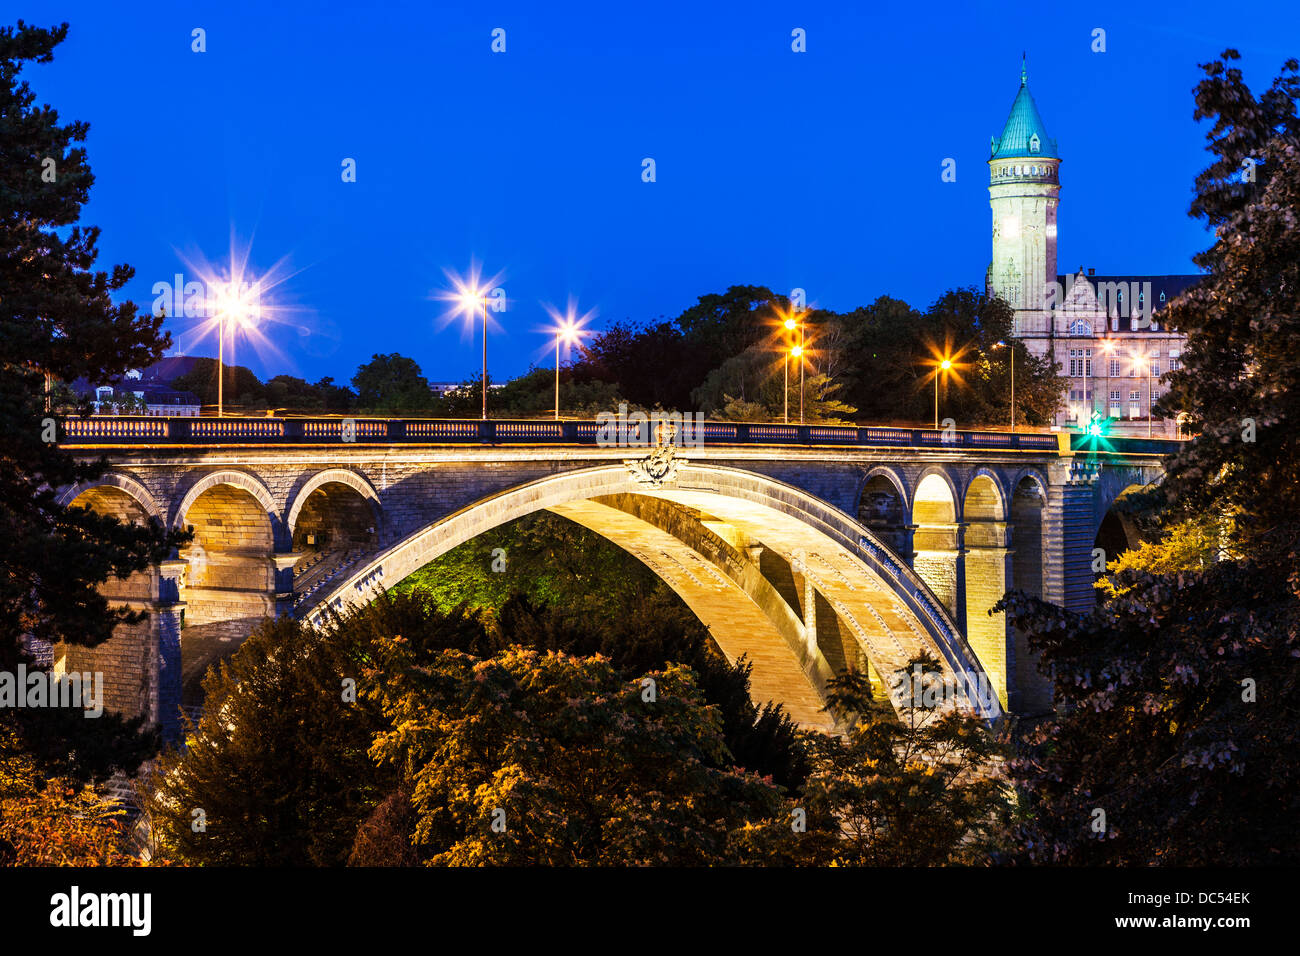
985, 60, 1061, 338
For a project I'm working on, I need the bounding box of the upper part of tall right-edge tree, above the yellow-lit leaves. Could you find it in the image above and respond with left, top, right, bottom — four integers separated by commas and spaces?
1151, 49, 1300, 582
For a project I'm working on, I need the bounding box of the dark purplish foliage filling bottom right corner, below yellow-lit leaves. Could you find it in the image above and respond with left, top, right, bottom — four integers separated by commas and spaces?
1002, 561, 1300, 866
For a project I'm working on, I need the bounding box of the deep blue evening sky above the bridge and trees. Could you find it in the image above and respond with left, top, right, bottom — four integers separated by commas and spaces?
12, 0, 1300, 380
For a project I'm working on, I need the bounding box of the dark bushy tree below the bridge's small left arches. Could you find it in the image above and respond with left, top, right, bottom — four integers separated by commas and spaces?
147, 618, 397, 866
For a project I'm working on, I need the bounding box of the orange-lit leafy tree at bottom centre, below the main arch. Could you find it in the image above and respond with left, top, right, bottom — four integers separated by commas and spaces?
372, 643, 780, 866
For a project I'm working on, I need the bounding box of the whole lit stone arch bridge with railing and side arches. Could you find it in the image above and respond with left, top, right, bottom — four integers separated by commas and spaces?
55, 418, 1173, 736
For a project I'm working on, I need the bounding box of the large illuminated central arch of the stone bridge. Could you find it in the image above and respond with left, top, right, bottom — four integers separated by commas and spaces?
307, 463, 1001, 727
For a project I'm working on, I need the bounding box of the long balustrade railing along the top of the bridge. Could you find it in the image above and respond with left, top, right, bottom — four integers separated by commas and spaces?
61, 415, 1178, 454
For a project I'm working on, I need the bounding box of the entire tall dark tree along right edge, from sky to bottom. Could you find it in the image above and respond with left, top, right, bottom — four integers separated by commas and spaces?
1001, 51, 1300, 866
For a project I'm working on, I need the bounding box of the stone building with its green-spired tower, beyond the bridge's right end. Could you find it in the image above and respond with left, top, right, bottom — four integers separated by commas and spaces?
985, 65, 1200, 436
